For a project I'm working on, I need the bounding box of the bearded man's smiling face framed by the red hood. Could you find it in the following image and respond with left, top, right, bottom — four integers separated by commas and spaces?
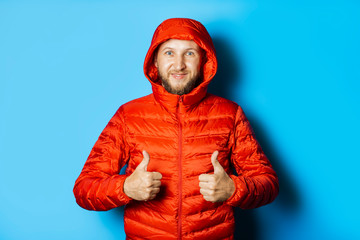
155, 39, 202, 95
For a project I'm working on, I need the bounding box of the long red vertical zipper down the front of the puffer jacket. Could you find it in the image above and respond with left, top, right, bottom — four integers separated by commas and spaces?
176, 96, 182, 239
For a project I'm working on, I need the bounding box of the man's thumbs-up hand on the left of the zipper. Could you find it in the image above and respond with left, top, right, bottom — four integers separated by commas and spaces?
124, 150, 162, 201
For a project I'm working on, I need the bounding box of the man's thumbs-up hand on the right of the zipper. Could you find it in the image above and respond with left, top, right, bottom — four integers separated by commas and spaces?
199, 151, 235, 202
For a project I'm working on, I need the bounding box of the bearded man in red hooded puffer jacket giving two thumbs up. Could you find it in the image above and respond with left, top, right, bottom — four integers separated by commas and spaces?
74, 18, 278, 239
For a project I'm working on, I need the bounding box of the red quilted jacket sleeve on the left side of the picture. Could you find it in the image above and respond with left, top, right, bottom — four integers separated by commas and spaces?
73, 107, 131, 211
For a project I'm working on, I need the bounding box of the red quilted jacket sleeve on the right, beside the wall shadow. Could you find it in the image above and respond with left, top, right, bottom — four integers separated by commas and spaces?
226, 107, 279, 209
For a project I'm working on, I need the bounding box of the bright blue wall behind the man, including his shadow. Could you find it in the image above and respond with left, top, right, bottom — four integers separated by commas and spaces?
0, 0, 360, 240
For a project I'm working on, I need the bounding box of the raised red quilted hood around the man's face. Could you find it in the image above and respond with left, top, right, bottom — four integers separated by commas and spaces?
144, 18, 217, 107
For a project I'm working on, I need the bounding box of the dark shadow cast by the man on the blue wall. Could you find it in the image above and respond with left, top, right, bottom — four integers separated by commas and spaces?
209, 37, 301, 240
